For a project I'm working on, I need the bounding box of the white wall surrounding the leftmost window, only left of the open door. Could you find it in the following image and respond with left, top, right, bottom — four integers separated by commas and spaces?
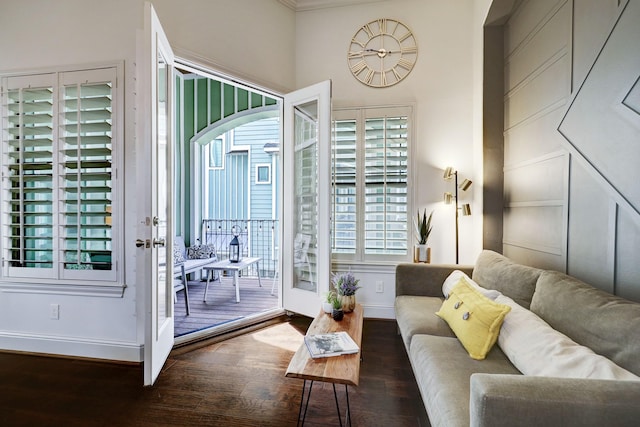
0, 0, 142, 360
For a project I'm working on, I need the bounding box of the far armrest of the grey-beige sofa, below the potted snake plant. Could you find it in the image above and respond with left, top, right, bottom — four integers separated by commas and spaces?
396, 263, 473, 297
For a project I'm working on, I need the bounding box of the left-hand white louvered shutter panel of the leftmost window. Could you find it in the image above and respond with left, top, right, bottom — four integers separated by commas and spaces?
2, 74, 55, 277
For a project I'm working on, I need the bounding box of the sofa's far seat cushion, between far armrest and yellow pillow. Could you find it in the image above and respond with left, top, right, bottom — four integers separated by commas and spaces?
395, 295, 455, 352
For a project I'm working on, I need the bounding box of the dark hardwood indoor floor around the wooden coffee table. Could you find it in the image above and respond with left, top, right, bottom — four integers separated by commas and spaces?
0, 317, 429, 427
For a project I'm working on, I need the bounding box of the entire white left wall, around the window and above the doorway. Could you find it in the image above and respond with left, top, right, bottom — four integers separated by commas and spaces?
0, 0, 295, 361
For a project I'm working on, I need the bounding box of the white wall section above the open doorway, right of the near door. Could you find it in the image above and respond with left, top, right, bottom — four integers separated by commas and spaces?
151, 0, 295, 93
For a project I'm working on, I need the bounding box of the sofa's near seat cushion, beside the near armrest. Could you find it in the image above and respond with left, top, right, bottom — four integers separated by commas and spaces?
409, 335, 519, 427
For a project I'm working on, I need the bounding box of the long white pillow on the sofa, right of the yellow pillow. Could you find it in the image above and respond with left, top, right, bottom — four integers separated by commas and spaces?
496, 295, 640, 381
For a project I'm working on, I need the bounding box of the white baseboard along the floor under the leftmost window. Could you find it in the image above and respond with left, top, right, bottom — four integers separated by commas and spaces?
0, 332, 144, 363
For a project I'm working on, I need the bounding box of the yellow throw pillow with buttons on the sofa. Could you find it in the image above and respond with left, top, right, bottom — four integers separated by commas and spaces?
436, 277, 511, 360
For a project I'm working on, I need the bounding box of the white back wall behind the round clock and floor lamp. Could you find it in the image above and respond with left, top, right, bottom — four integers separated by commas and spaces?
296, 0, 489, 318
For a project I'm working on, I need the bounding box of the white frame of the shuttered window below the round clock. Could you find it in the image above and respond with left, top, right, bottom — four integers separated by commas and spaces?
331, 104, 415, 265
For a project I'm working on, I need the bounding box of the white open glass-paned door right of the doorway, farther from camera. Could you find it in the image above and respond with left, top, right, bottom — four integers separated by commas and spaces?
281, 81, 331, 317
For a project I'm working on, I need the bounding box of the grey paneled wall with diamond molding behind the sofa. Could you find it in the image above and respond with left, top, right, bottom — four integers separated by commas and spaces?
502, 0, 640, 300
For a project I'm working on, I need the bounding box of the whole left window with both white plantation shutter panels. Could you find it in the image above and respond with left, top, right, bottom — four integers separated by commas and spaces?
0, 67, 120, 285
